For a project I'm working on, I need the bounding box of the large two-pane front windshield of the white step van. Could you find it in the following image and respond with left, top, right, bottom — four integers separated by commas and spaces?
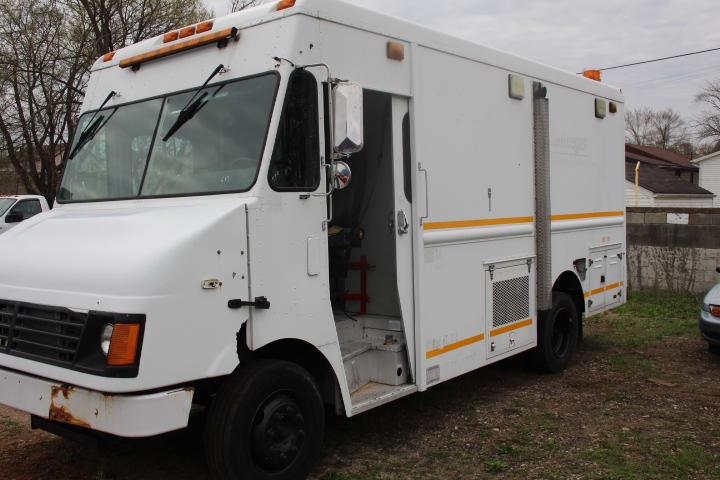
57, 73, 278, 202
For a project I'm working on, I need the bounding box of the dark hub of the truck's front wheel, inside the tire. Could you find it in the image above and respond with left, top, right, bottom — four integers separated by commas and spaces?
252, 394, 306, 472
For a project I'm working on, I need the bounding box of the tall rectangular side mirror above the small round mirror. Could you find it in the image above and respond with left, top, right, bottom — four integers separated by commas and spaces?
333, 82, 363, 155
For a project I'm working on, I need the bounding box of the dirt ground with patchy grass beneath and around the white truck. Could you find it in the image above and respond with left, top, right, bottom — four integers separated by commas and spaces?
0, 294, 720, 480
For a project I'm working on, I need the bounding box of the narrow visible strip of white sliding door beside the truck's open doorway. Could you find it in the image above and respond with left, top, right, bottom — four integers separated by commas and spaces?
392, 97, 415, 378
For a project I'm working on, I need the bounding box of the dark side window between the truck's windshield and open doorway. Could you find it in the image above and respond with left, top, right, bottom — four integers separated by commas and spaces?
268, 70, 320, 191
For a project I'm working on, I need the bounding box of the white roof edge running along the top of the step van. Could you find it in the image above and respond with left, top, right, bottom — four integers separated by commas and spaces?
93, 0, 624, 102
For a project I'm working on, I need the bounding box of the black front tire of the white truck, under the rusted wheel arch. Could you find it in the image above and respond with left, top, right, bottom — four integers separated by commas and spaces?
205, 360, 325, 480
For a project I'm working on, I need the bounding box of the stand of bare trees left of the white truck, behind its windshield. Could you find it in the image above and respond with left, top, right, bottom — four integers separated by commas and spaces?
0, 0, 211, 199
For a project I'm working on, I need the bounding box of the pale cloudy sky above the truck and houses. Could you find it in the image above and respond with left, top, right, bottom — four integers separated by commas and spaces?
206, 0, 720, 125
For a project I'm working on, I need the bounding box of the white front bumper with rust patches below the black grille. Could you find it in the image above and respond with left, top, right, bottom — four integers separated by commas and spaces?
0, 369, 193, 437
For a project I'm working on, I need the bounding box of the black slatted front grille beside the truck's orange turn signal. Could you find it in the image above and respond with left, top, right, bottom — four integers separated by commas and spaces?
0, 300, 88, 365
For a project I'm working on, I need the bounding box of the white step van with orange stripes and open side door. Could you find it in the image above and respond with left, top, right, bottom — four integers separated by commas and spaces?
0, 0, 626, 479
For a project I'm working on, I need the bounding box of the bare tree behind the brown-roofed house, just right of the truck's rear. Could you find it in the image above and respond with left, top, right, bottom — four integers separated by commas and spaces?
625, 108, 692, 153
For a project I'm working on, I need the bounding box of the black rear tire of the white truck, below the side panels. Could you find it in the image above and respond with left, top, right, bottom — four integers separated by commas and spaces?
527, 292, 580, 373
